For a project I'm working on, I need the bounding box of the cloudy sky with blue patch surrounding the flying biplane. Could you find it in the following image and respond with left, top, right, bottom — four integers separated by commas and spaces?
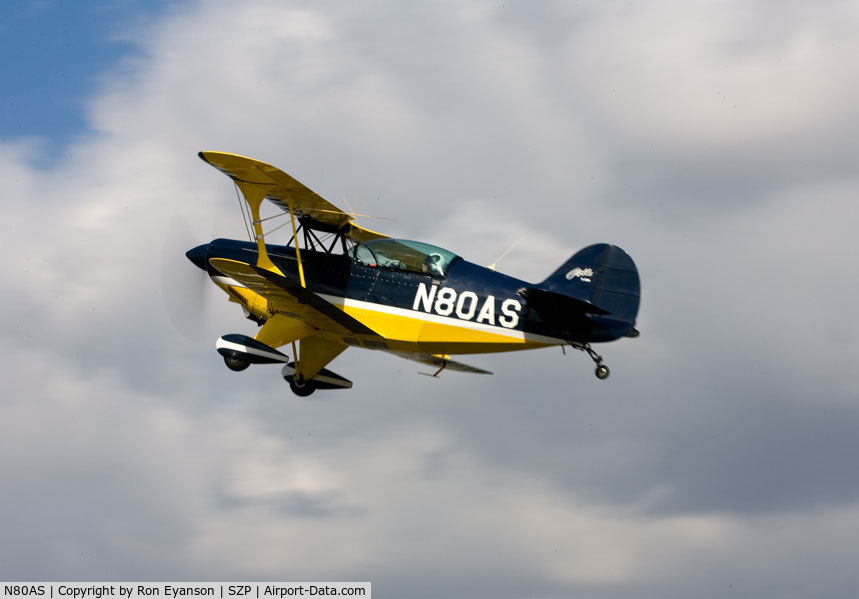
0, 0, 859, 599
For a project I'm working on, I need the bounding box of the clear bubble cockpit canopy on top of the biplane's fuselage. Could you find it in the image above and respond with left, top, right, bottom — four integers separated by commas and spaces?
352, 237, 458, 277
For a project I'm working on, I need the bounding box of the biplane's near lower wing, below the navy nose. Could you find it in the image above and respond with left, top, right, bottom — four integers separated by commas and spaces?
209, 258, 380, 337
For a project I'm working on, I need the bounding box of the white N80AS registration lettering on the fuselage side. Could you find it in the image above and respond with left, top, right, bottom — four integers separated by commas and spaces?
412, 283, 522, 329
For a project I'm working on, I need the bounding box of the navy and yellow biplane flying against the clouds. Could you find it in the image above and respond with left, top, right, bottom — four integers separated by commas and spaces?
186, 152, 640, 396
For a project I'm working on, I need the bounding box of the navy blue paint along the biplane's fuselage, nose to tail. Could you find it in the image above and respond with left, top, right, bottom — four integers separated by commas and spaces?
187, 239, 640, 342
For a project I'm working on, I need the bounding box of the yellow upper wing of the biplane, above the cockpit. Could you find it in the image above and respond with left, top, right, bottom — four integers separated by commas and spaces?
199, 152, 387, 243
